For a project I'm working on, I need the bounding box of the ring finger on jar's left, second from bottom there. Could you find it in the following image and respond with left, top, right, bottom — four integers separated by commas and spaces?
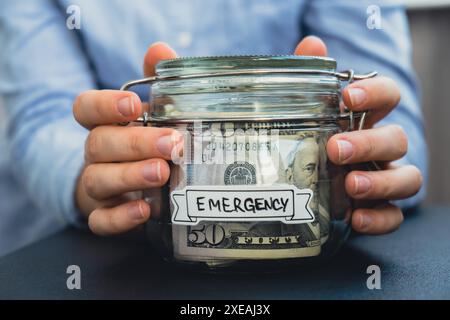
82, 159, 170, 200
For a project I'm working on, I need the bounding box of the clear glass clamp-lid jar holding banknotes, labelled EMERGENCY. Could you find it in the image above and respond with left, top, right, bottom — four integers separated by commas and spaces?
122, 56, 375, 271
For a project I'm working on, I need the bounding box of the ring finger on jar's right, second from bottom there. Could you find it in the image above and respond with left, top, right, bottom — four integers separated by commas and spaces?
345, 165, 422, 200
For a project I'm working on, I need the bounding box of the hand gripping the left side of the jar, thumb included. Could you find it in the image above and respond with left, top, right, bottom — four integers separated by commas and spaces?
73, 43, 182, 235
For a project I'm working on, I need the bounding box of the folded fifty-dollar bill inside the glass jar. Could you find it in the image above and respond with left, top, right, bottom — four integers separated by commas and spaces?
170, 123, 330, 265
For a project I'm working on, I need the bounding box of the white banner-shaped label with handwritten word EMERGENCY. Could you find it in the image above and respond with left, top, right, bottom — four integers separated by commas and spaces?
171, 185, 314, 225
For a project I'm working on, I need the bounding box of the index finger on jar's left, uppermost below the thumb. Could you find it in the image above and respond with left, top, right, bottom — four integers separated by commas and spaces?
73, 90, 142, 129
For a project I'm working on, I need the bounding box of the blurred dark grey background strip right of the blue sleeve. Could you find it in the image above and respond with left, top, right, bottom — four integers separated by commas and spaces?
0, 0, 450, 204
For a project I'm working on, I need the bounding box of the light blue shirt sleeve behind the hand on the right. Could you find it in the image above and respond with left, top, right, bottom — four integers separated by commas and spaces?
302, 0, 427, 208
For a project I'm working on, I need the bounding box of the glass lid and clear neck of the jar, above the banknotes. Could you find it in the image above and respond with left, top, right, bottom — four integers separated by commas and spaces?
151, 55, 340, 121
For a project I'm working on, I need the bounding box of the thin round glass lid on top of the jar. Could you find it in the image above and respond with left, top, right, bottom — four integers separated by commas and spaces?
155, 55, 336, 77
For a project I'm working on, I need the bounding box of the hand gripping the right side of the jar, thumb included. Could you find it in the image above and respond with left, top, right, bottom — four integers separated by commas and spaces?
295, 37, 422, 234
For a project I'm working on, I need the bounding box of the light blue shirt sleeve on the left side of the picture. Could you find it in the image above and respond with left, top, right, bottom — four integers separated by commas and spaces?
0, 0, 95, 226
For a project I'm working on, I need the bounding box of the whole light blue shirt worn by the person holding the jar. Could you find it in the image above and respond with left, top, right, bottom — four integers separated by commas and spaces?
0, 0, 427, 255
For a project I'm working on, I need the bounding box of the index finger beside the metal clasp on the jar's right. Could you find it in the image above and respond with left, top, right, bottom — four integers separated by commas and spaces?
342, 77, 400, 127
